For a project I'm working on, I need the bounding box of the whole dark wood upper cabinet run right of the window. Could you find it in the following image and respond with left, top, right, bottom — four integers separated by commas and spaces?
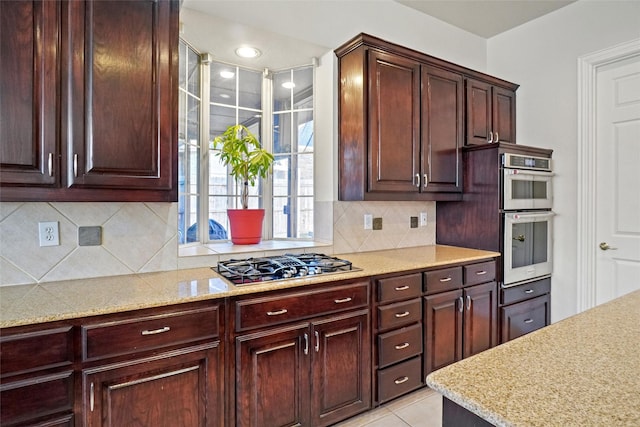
335, 34, 518, 201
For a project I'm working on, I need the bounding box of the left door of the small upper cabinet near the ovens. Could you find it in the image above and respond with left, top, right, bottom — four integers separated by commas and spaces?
466, 79, 493, 145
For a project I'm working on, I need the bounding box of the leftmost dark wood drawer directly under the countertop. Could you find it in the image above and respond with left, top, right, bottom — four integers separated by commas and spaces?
0, 326, 73, 377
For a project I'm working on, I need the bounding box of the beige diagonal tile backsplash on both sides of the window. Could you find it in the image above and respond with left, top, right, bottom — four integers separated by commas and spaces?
0, 201, 436, 285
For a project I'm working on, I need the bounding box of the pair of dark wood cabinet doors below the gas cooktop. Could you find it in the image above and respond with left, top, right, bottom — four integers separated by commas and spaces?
236, 310, 371, 427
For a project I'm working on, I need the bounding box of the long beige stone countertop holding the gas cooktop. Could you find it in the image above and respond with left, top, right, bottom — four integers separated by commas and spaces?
0, 245, 500, 328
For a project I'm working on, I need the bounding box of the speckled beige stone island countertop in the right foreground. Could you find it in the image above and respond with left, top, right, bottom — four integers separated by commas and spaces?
427, 291, 640, 427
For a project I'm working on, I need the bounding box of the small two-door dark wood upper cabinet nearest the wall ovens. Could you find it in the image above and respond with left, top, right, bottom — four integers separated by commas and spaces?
466, 79, 516, 145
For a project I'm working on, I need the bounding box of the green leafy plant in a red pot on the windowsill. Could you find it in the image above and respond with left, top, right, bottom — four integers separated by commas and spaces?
213, 125, 274, 245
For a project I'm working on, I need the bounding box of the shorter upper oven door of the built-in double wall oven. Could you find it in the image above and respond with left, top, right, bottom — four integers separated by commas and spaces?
502, 168, 553, 211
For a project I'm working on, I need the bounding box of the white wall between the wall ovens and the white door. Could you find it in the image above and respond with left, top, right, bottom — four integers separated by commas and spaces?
487, 0, 640, 322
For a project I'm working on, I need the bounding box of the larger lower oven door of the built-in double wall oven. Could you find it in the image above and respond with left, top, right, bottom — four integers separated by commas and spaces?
504, 211, 554, 286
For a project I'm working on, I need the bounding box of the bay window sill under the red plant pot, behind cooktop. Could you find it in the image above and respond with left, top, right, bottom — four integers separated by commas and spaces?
178, 240, 332, 262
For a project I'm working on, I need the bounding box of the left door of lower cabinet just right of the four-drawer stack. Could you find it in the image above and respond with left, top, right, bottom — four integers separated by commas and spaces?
424, 290, 464, 376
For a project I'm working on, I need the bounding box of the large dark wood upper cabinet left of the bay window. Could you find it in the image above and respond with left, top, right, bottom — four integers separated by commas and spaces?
0, 0, 179, 201
